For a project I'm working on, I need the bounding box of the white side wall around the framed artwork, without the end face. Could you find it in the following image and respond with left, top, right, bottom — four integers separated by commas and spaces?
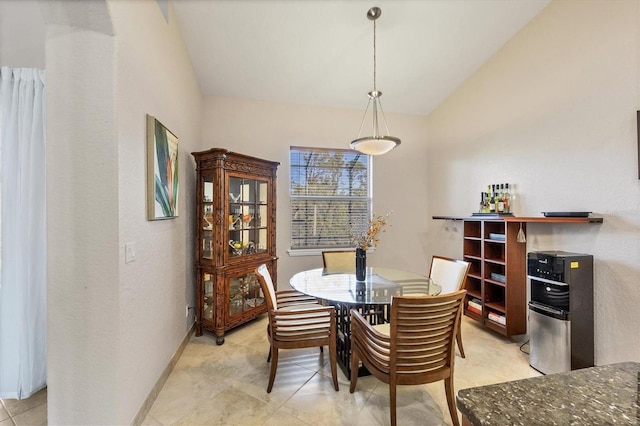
109, 0, 201, 424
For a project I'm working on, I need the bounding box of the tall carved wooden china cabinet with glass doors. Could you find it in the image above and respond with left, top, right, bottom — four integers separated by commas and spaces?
192, 148, 280, 345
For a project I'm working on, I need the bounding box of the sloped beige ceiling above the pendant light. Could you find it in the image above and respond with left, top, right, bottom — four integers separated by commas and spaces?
173, 0, 549, 115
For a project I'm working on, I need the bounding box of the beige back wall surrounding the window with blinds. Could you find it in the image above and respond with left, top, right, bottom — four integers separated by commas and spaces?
201, 97, 429, 282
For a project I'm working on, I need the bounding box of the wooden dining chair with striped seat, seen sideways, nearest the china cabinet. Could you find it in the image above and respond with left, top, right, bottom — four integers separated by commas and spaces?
255, 265, 338, 393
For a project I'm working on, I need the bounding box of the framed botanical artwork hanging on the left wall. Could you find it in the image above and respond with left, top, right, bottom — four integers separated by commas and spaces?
147, 115, 179, 220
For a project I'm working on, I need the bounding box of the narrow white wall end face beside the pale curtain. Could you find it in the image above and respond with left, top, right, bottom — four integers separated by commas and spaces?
46, 8, 119, 424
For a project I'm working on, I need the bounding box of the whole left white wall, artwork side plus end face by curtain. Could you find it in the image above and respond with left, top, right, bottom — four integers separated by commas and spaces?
46, 0, 201, 424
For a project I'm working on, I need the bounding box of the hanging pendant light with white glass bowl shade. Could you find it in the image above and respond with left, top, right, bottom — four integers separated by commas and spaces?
350, 7, 400, 155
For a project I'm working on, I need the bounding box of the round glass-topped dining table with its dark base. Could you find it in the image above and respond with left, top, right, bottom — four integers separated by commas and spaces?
289, 267, 442, 377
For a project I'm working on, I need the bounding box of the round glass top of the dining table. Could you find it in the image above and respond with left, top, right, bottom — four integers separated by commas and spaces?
289, 267, 442, 305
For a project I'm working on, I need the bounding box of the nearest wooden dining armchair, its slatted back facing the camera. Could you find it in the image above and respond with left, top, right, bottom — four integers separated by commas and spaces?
349, 290, 467, 426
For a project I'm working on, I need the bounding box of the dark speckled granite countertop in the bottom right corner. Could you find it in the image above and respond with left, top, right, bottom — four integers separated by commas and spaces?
456, 362, 640, 426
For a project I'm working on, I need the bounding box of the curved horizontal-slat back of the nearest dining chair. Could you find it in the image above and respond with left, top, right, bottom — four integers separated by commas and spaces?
390, 290, 466, 376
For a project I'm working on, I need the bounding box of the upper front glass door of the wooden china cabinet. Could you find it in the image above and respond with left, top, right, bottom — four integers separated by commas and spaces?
227, 176, 269, 258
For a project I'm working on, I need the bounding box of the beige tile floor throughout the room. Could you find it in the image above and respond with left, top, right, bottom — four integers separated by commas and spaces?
0, 317, 540, 426
